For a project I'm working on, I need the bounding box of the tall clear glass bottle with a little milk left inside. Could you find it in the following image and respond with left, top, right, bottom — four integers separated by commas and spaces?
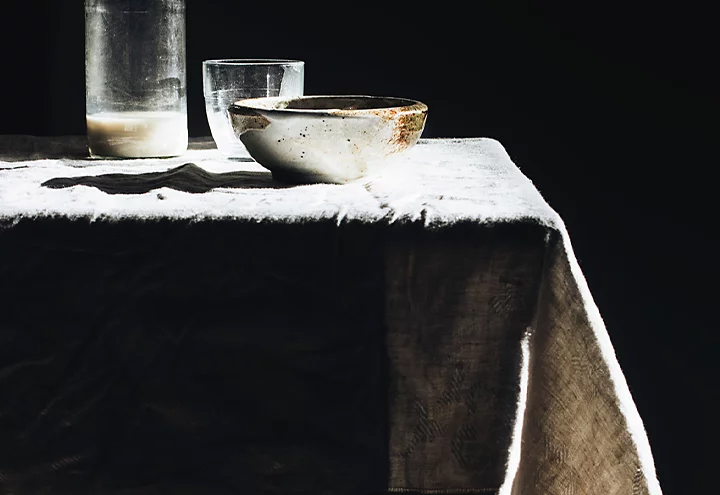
85, 0, 188, 158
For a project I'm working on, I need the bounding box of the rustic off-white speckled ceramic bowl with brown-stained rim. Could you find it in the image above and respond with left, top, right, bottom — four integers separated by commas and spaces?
228, 96, 428, 184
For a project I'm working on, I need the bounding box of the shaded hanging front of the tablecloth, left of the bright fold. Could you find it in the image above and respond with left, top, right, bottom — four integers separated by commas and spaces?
0, 220, 545, 495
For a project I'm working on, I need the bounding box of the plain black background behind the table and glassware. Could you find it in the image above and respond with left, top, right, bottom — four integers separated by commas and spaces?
0, 0, 720, 494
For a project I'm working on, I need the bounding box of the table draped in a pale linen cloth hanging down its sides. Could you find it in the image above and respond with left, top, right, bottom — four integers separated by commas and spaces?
0, 136, 661, 495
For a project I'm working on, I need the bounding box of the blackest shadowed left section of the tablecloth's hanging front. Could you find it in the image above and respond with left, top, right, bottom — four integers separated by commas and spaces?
0, 220, 388, 495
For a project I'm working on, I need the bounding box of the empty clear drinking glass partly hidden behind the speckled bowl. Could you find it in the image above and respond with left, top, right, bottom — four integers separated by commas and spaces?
203, 59, 305, 157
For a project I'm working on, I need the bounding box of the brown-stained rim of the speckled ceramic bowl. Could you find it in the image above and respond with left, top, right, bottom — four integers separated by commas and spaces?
228, 95, 428, 116
